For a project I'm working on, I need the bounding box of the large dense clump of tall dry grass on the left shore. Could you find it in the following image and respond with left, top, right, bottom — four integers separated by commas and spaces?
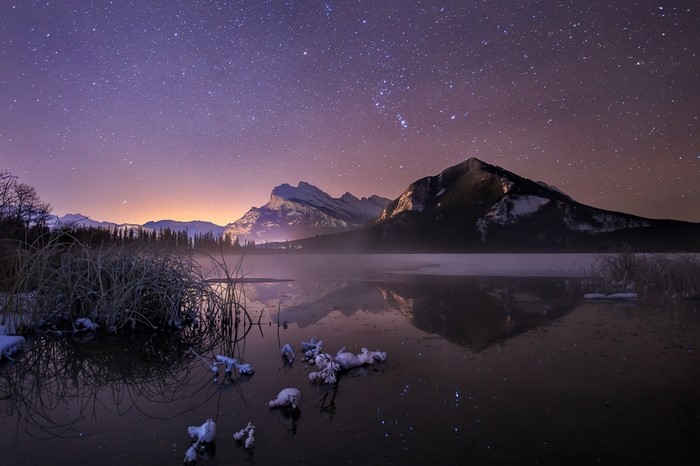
0, 235, 212, 332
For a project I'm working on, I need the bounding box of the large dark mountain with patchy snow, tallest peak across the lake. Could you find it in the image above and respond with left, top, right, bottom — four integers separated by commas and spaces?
296, 158, 700, 252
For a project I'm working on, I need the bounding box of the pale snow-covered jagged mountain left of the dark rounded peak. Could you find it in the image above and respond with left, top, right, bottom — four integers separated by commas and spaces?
225, 182, 389, 243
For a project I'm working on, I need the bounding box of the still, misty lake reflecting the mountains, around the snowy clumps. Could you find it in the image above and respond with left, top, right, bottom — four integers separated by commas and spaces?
0, 255, 700, 466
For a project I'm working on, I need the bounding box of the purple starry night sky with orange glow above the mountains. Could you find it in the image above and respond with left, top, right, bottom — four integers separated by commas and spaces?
0, 0, 700, 225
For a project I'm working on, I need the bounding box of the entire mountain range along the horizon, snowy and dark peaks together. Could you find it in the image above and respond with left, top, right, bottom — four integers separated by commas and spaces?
50, 158, 700, 252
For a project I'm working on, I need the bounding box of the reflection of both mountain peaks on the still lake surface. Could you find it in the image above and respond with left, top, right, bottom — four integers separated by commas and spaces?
241, 276, 581, 351
